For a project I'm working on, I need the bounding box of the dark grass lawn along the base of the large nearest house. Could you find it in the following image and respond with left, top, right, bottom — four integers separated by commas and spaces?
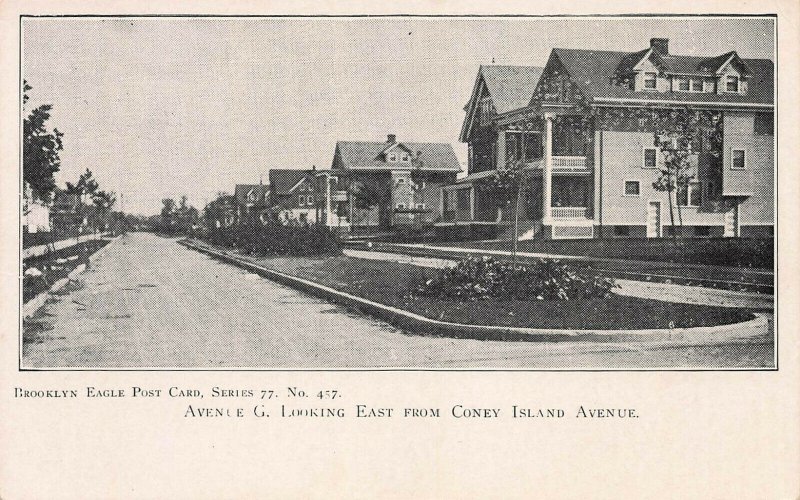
466, 238, 774, 269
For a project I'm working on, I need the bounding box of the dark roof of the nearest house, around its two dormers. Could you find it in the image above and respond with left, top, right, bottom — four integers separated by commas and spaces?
551, 49, 774, 104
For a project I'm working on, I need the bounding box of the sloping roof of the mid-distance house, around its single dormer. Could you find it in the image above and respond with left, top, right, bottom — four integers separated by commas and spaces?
332, 141, 461, 173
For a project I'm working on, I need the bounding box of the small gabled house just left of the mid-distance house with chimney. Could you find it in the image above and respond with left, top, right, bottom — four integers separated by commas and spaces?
269, 169, 319, 224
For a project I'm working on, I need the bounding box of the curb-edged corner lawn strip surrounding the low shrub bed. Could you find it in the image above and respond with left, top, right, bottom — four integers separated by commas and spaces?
195, 241, 753, 330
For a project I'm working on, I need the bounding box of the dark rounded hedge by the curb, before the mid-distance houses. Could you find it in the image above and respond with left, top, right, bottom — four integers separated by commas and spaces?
205, 222, 341, 257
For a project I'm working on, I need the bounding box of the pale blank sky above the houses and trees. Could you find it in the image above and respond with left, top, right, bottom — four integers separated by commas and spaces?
22, 17, 774, 215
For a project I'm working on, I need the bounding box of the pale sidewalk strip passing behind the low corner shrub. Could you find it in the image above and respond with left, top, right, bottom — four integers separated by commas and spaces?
344, 249, 775, 311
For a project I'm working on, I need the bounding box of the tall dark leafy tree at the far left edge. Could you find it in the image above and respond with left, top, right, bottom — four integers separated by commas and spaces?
22, 81, 64, 201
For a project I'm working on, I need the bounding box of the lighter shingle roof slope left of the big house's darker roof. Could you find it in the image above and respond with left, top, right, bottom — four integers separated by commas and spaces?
480, 65, 544, 114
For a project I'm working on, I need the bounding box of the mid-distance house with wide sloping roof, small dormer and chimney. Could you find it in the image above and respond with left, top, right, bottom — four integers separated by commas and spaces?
316, 134, 461, 229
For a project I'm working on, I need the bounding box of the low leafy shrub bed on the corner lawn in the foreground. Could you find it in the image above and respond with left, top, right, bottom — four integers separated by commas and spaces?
417, 257, 618, 300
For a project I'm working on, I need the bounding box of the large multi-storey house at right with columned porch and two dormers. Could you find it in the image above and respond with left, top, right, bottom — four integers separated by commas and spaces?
440, 38, 774, 238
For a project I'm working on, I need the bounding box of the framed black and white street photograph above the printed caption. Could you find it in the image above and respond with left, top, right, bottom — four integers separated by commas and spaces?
19, 14, 780, 371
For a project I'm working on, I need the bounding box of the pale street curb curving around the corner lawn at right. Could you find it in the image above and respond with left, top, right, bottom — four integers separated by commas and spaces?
178, 240, 768, 342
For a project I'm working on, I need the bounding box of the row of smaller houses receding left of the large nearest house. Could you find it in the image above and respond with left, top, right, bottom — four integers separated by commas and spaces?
222, 134, 461, 230
